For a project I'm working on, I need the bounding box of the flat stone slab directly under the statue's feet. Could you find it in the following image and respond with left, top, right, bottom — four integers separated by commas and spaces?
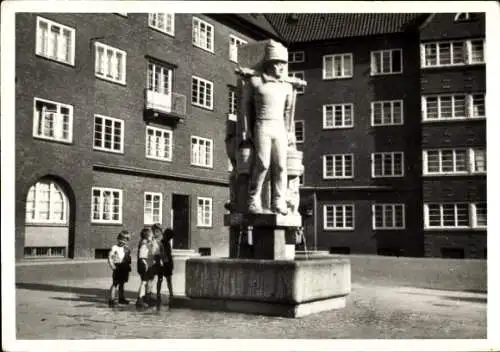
224, 213, 302, 227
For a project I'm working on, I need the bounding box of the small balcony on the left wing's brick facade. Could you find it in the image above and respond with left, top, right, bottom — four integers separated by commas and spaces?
145, 89, 186, 124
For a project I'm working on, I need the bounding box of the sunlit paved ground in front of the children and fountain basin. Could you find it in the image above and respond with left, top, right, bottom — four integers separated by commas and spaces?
16, 279, 486, 340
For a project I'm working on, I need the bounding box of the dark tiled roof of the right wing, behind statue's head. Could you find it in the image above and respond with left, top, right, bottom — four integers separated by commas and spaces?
265, 13, 428, 43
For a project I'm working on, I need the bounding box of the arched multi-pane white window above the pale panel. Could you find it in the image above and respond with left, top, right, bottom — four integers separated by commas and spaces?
26, 180, 68, 224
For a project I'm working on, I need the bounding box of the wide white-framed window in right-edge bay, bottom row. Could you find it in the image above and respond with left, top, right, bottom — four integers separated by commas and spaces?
424, 202, 487, 229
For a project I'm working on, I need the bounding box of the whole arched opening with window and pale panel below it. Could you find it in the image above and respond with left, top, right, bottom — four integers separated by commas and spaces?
24, 178, 70, 258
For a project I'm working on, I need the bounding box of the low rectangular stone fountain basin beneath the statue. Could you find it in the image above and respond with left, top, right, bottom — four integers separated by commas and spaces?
184, 257, 351, 317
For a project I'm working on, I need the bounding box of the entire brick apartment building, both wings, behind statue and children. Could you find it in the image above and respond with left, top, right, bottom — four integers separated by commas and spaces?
15, 13, 486, 260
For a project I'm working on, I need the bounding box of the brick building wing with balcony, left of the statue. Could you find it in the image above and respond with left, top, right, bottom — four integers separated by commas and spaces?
15, 13, 277, 260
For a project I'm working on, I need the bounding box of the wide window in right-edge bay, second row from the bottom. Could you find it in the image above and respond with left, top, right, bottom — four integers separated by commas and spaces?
423, 148, 486, 175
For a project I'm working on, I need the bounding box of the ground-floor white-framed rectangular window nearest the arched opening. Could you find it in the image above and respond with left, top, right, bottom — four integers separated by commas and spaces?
92, 187, 123, 224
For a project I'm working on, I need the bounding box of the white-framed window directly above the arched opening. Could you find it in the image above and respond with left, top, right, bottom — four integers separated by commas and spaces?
33, 98, 73, 143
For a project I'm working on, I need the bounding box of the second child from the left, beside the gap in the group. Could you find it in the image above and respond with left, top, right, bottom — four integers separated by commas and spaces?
135, 227, 153, 308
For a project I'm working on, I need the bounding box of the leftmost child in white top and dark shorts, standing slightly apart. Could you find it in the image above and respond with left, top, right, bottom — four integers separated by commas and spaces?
108, 230, 132, 307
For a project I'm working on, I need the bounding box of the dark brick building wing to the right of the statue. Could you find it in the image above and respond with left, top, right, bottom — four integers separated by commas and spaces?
267, 13, 486, 257
